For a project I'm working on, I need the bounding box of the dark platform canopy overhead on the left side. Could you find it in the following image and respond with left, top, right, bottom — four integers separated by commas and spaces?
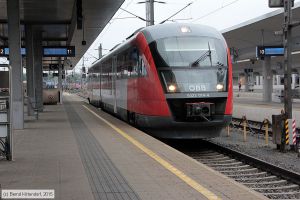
0, 0, 124, 67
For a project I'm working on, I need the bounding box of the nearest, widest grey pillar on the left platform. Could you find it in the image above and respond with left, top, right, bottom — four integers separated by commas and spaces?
7, 0, 24, 129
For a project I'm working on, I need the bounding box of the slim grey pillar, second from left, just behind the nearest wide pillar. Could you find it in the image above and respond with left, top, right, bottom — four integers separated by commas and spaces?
25, 25, 35, 116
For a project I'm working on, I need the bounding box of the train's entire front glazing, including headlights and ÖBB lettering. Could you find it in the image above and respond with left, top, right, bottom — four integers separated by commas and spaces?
150, 37, 228, 93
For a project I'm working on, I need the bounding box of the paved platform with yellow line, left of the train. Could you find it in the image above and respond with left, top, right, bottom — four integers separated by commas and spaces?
0, 94, 266, 200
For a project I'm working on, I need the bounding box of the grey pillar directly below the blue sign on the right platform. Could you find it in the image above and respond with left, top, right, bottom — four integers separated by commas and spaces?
262, 57, 273, 102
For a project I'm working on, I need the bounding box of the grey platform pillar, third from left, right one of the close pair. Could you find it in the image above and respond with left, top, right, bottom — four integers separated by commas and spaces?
33, 28, 44, 112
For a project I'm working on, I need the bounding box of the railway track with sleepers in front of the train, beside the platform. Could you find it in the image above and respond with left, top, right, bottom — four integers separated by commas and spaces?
166, 141, 300, 199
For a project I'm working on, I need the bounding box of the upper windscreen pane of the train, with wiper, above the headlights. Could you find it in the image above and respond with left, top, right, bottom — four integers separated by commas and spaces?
150, 36, 227, 68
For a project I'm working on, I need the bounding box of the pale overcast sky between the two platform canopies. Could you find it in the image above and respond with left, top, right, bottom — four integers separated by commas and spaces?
76, 0, 300, 70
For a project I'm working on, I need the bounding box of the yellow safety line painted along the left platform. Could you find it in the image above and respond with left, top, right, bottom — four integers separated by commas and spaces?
82, 105, 221, 200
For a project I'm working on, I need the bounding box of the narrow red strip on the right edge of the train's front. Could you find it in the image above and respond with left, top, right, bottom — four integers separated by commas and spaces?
224, 49, 233, 115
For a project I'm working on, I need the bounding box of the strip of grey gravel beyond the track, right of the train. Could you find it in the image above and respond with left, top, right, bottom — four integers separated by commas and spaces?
211, 130, 300, 173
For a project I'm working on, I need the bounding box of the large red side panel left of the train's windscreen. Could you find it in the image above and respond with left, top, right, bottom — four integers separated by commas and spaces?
127, 33, 171, 116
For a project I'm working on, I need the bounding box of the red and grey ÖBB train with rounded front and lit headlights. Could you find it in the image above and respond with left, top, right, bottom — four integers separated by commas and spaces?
88, 23, 233, 139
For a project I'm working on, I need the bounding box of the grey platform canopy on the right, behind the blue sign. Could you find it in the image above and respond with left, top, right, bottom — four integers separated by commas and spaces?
222, 3, 300, 73
